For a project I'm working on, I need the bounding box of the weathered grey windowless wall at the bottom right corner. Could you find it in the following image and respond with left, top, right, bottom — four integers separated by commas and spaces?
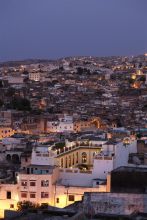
83, 192, 147, 217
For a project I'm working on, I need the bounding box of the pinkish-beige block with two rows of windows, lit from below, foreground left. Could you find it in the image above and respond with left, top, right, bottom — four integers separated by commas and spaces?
18, 165, 59, 205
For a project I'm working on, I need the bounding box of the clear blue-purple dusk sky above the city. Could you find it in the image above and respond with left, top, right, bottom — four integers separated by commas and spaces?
0, 0, 147, 61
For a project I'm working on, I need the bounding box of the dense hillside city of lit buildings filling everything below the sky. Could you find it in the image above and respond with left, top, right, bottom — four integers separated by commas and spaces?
0, 54, 147, 220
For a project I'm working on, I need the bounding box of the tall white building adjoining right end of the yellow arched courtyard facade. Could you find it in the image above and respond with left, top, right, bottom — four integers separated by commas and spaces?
92, 140, 137, 178
